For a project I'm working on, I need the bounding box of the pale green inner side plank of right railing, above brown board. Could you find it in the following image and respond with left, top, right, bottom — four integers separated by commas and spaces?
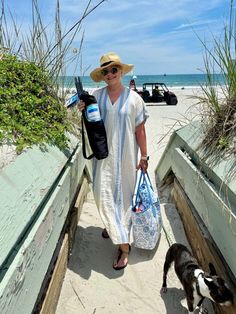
172, 148, 236, 278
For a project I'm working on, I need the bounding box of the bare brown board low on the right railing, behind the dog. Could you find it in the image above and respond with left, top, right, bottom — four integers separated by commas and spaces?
173, 179, 236, 314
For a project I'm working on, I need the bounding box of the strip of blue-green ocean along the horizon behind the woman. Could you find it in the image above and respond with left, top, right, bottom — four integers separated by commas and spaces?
61, 74, 224, 89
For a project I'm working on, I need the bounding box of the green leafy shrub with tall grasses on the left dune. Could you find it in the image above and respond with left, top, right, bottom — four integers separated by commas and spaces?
0, 0, 105, 153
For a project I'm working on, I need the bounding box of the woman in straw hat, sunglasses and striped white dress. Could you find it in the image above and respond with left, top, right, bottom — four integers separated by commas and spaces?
79, 52, 148, 270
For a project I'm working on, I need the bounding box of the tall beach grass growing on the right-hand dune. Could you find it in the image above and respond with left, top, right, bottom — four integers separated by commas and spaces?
194, 0, 236, 159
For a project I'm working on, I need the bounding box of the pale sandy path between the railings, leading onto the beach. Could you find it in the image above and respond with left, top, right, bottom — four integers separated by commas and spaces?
56, 89, 213, 314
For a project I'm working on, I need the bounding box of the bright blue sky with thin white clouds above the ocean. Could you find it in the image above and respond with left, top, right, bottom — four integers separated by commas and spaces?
2, 0, 233, 75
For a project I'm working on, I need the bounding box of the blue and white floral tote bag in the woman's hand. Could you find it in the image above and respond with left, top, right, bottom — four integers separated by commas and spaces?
131, 170, 162, 250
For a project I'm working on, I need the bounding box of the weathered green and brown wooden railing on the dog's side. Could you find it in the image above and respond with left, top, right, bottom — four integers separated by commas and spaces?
156, 123, 236, 314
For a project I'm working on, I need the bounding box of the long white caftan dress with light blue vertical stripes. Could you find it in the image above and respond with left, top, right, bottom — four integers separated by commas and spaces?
93, 87, 148, 244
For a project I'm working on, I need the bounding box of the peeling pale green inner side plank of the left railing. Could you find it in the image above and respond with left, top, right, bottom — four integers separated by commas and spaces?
0, 145, 85, 314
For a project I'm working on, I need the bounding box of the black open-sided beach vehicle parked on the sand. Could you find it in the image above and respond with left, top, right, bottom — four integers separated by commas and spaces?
137, 83, 178, 105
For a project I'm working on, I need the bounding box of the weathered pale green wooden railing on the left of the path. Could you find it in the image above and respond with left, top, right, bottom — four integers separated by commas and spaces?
0, 136, 91, 314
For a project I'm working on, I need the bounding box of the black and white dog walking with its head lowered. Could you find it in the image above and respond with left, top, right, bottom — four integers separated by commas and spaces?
162, 243, 233, 313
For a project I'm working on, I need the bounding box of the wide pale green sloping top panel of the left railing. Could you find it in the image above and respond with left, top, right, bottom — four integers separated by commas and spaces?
0, 137, 79, 268
